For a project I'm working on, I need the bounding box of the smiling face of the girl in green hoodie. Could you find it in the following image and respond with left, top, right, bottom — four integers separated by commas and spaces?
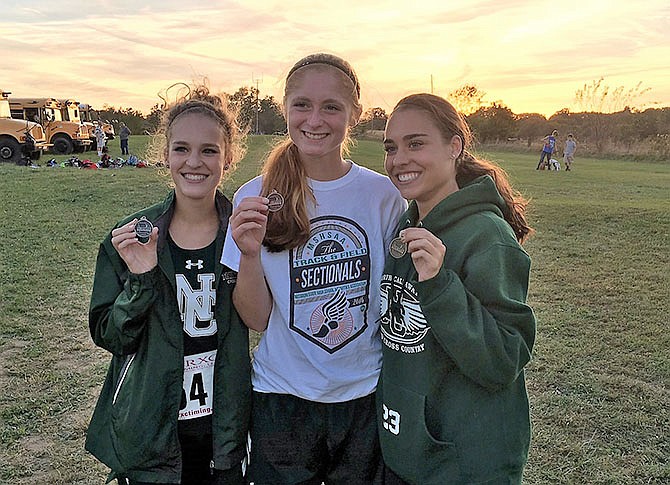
384, 108, 462, 218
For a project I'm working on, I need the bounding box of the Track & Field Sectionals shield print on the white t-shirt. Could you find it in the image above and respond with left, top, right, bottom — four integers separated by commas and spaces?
289, 216, 370, 353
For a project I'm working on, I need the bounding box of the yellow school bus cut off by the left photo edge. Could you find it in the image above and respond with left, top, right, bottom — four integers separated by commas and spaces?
0, 89, 47, 163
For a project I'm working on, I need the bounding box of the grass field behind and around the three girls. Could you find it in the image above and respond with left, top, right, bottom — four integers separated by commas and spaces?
0, 137, 670, 485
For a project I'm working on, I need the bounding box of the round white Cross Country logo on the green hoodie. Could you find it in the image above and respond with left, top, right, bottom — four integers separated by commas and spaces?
380, 274, 430, 353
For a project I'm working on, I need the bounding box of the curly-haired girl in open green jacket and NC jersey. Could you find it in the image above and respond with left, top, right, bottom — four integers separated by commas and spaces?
86, 87, 251, 485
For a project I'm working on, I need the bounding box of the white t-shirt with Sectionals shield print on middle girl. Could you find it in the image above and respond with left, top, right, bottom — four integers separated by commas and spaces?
221, 162, 407, 403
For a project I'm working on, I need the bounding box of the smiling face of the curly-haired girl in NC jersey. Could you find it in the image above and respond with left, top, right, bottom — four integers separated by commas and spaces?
166, 113, 229, 201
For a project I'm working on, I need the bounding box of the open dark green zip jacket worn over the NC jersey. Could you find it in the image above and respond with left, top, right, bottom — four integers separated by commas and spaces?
86, 192, 251, 483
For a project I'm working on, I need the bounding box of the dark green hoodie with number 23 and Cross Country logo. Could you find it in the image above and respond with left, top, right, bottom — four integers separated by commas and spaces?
377, 176, 535, 485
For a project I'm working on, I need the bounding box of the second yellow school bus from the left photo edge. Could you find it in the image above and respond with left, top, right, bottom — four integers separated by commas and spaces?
9, 98, 91, 155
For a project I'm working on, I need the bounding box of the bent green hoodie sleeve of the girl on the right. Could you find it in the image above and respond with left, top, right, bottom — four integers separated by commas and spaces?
415, 243, 535, 390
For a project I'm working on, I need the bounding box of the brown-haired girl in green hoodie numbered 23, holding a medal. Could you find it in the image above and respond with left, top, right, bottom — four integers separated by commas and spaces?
377, 94, 535, 485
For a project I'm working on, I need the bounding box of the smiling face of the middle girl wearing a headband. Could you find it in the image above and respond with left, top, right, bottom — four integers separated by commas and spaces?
284, 65, 360, 168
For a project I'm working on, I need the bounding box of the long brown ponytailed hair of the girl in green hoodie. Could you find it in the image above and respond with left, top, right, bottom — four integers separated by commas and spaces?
391, 93, 533, 243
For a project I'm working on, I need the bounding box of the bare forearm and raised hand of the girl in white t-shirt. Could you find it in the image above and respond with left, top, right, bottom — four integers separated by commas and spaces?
229, 197, 272, 332
